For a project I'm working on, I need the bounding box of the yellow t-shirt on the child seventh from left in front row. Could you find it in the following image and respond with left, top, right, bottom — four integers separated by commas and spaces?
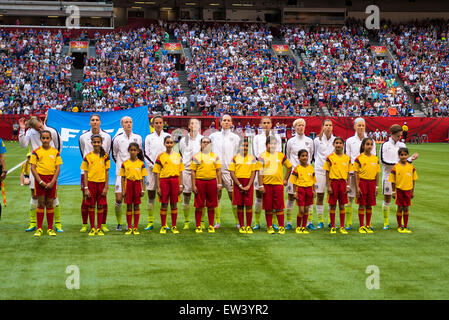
259, 151, 292, 185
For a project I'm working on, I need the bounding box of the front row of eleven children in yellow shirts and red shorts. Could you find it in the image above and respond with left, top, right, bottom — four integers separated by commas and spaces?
24, 130, 417, 236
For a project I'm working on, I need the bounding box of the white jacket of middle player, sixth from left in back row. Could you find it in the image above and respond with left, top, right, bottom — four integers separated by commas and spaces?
209, 130, 240, 171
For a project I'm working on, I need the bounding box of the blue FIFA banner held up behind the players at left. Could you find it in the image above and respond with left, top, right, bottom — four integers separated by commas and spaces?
47, 106, 150, 185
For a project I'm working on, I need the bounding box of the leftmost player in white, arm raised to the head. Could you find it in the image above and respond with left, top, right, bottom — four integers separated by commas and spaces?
19, 116, 64, 232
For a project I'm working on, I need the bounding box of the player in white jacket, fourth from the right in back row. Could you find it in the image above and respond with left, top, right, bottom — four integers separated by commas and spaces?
285, 118, 315, 230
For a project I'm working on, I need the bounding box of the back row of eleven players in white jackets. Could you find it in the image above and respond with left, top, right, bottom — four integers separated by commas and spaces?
19, 115, 417, 229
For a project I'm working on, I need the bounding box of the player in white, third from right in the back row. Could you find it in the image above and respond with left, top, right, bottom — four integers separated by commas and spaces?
313, 119, 335, 229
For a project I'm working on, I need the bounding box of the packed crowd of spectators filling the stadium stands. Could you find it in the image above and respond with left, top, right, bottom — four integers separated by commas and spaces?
0, 23, 449, 117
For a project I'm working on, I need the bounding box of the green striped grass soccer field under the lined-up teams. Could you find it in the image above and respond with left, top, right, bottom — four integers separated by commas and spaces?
0, 142, 449, 300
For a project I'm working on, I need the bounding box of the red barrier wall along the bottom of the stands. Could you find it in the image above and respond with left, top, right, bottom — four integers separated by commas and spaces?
0, 115, 449, 142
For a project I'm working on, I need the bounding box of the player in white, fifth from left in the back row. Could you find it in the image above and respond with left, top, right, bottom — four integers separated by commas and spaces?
179, 119, 203, 230
